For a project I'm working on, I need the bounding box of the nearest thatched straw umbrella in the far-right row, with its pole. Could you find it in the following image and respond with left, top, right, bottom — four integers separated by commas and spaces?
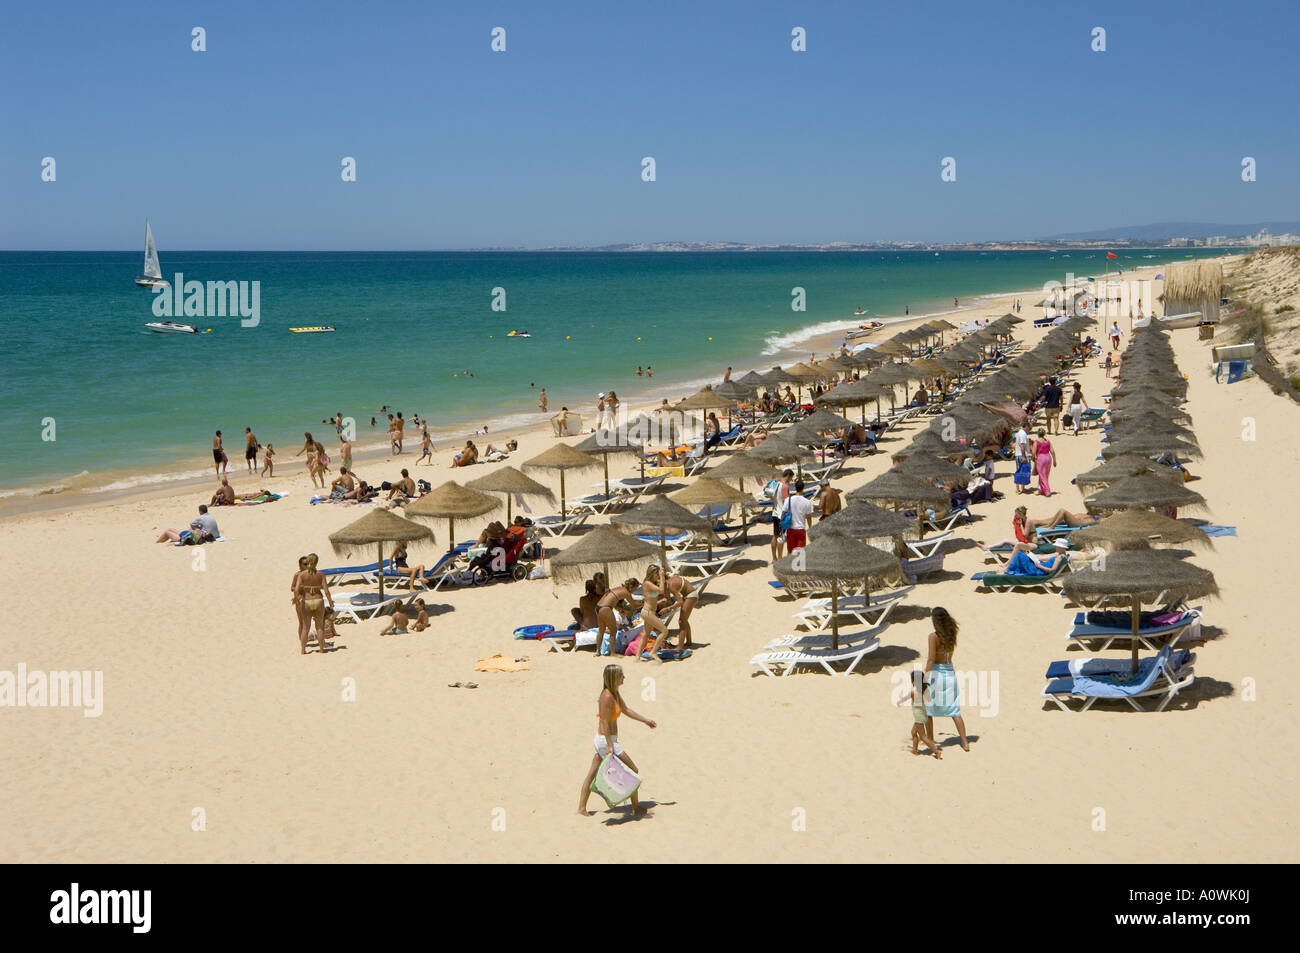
1061, 549, 1218, 675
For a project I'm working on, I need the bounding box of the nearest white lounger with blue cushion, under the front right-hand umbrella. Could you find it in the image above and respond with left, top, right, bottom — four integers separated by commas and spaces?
1043, 646, 1196, 711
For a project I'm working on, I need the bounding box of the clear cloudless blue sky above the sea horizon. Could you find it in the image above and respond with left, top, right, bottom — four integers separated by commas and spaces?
0, 0, 1300, 250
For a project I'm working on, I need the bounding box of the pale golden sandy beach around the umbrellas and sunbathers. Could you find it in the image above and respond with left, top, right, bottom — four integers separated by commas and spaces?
0, 260, 1300, 863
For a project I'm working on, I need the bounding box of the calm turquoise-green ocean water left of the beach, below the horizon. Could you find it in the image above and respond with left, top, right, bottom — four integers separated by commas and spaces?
0, 249, 1237, 491
